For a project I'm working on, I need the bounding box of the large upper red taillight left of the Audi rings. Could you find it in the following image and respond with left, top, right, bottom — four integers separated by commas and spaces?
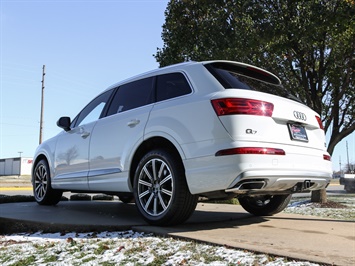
211, 98, 274, 117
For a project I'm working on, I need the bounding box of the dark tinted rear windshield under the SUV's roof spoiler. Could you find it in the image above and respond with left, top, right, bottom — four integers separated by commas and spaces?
205, 62, 300, 102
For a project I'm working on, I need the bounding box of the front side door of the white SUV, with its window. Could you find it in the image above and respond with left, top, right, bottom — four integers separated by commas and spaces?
53, 90, 112, 190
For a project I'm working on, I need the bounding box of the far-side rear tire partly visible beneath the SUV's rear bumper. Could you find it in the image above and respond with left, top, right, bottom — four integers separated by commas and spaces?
238, 195, 291, 216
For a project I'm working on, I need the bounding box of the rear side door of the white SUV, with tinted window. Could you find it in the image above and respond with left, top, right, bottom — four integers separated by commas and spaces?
88, 77, 154, 192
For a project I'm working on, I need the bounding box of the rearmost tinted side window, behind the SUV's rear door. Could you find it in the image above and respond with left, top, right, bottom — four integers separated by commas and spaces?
157, 73, 191, 102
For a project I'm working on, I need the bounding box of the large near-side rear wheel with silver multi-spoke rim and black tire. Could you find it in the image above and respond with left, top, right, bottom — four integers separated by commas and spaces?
133, 149, 198, 226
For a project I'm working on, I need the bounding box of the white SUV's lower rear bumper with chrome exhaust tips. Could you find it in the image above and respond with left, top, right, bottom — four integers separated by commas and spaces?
184, 150, 332, 195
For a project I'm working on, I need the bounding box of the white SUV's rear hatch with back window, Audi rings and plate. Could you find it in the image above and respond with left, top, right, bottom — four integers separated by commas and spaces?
205, 61, 325, 151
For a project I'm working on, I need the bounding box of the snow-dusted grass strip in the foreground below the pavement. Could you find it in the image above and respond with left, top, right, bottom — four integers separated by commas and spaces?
0, 231, 318, 266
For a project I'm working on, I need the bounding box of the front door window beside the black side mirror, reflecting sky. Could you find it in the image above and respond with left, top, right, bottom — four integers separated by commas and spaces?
73, 90, 113, 127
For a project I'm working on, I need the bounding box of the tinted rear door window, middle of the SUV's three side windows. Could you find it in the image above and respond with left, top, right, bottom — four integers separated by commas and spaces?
107, 77, 154, 116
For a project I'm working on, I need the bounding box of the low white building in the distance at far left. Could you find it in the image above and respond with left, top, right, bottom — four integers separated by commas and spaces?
0, 157, 33, 176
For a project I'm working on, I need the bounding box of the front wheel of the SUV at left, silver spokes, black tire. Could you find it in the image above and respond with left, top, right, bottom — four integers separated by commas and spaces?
32, 159, 63, 205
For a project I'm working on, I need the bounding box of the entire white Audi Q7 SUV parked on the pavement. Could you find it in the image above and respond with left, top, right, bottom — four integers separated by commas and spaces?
32, 61, 332, 225
